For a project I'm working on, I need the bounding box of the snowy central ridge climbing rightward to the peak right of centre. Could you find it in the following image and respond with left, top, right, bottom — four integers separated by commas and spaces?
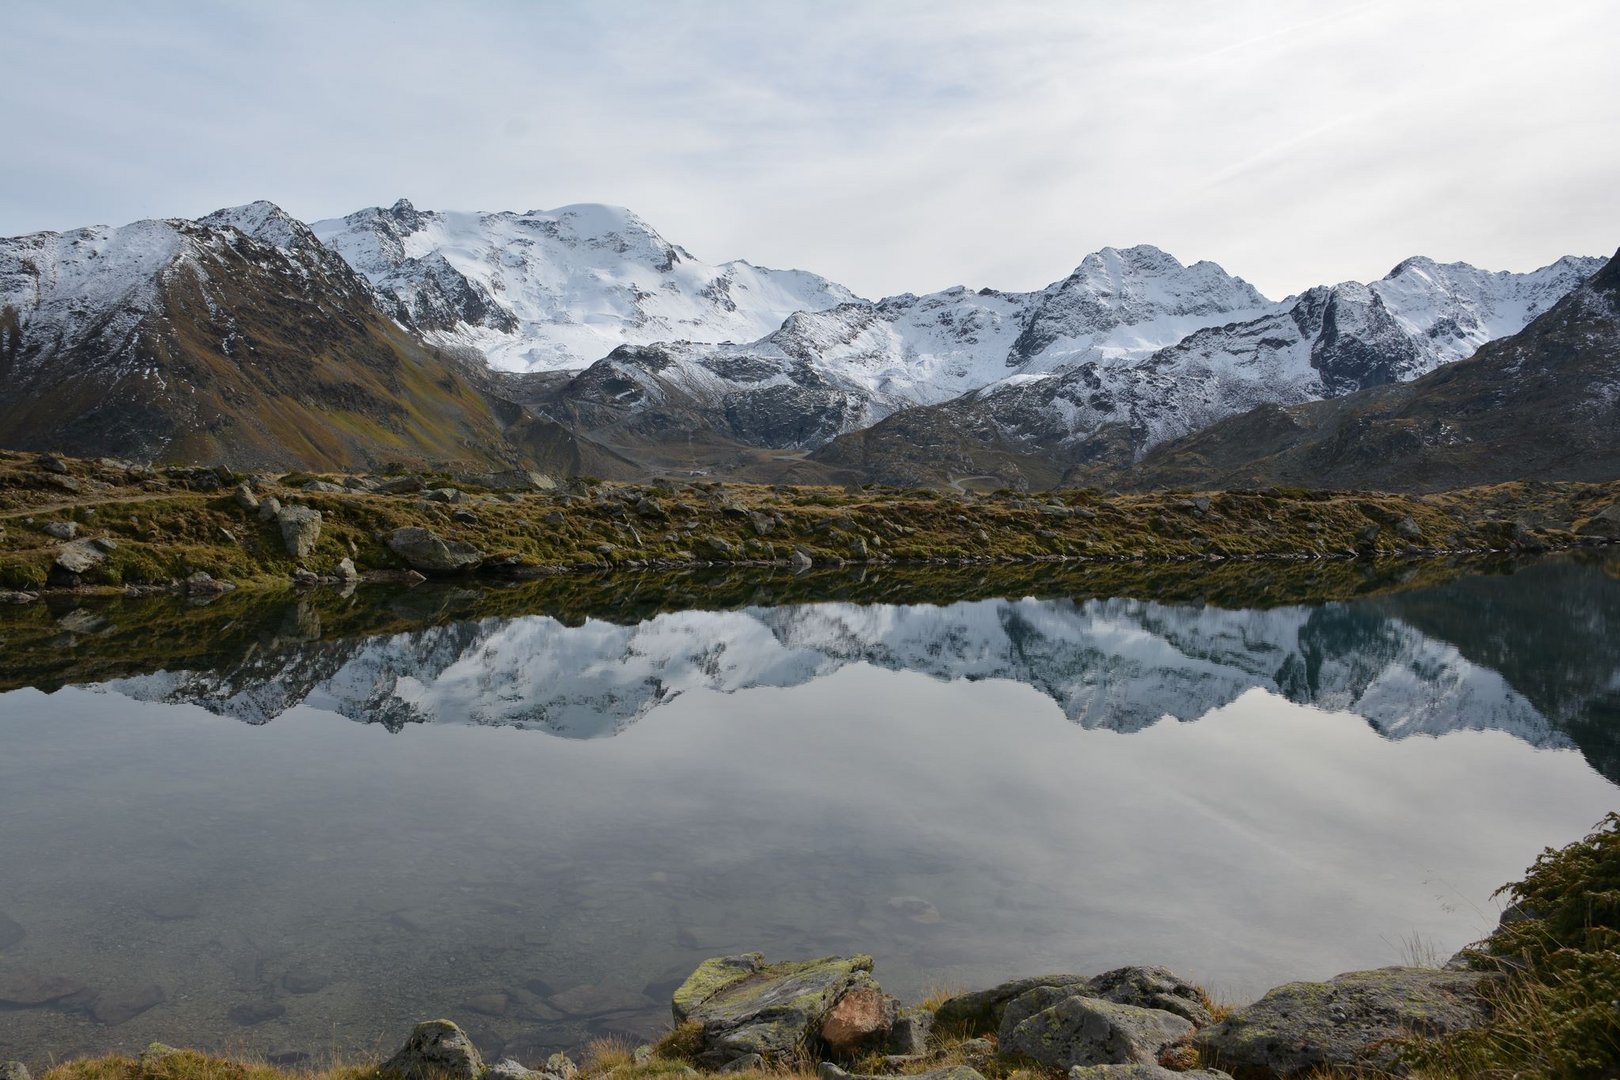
537, 244, 1275, 447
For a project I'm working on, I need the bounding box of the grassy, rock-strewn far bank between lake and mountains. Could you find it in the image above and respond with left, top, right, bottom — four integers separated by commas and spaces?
0, 452, 1620, 602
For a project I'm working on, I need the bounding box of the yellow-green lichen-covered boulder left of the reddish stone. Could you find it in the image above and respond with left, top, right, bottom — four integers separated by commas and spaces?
671, 952, 893, 1069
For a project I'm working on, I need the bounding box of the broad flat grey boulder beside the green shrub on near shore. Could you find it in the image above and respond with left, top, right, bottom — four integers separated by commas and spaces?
1194, 968, 1492, 1077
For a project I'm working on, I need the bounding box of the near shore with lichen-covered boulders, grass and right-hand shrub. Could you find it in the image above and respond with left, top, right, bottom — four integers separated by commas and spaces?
0, 813, 1620, 1080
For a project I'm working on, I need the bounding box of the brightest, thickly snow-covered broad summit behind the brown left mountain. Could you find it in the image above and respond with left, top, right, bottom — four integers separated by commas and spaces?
311, 199, 854, 371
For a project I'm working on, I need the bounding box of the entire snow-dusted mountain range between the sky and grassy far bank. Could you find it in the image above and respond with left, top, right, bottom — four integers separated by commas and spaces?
0, 199, 1615, 486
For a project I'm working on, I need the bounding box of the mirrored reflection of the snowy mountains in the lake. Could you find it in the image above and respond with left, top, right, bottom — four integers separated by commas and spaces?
102, 599, 1568, 757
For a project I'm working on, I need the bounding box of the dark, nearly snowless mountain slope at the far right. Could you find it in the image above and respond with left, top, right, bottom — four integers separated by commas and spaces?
1113, 254, 1620, 491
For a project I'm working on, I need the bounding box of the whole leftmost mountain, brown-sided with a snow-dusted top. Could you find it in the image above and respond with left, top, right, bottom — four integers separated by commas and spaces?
0, 202, 544, 466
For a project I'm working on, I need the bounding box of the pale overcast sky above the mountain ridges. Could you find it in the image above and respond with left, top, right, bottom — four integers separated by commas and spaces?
0, 0, 1620, 296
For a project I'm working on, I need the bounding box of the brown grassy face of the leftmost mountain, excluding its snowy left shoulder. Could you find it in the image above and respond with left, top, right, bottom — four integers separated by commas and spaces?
0, 223, 518, 468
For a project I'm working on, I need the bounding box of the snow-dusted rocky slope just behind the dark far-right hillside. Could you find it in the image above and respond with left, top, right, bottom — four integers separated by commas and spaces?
815, 257, 1602, 483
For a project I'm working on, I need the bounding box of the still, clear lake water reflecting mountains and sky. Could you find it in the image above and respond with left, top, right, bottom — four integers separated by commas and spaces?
0, 560, 1620, 1064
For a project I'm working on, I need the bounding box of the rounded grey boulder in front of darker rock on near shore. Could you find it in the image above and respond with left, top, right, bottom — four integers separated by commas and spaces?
1001, 997, 1196, 1069
